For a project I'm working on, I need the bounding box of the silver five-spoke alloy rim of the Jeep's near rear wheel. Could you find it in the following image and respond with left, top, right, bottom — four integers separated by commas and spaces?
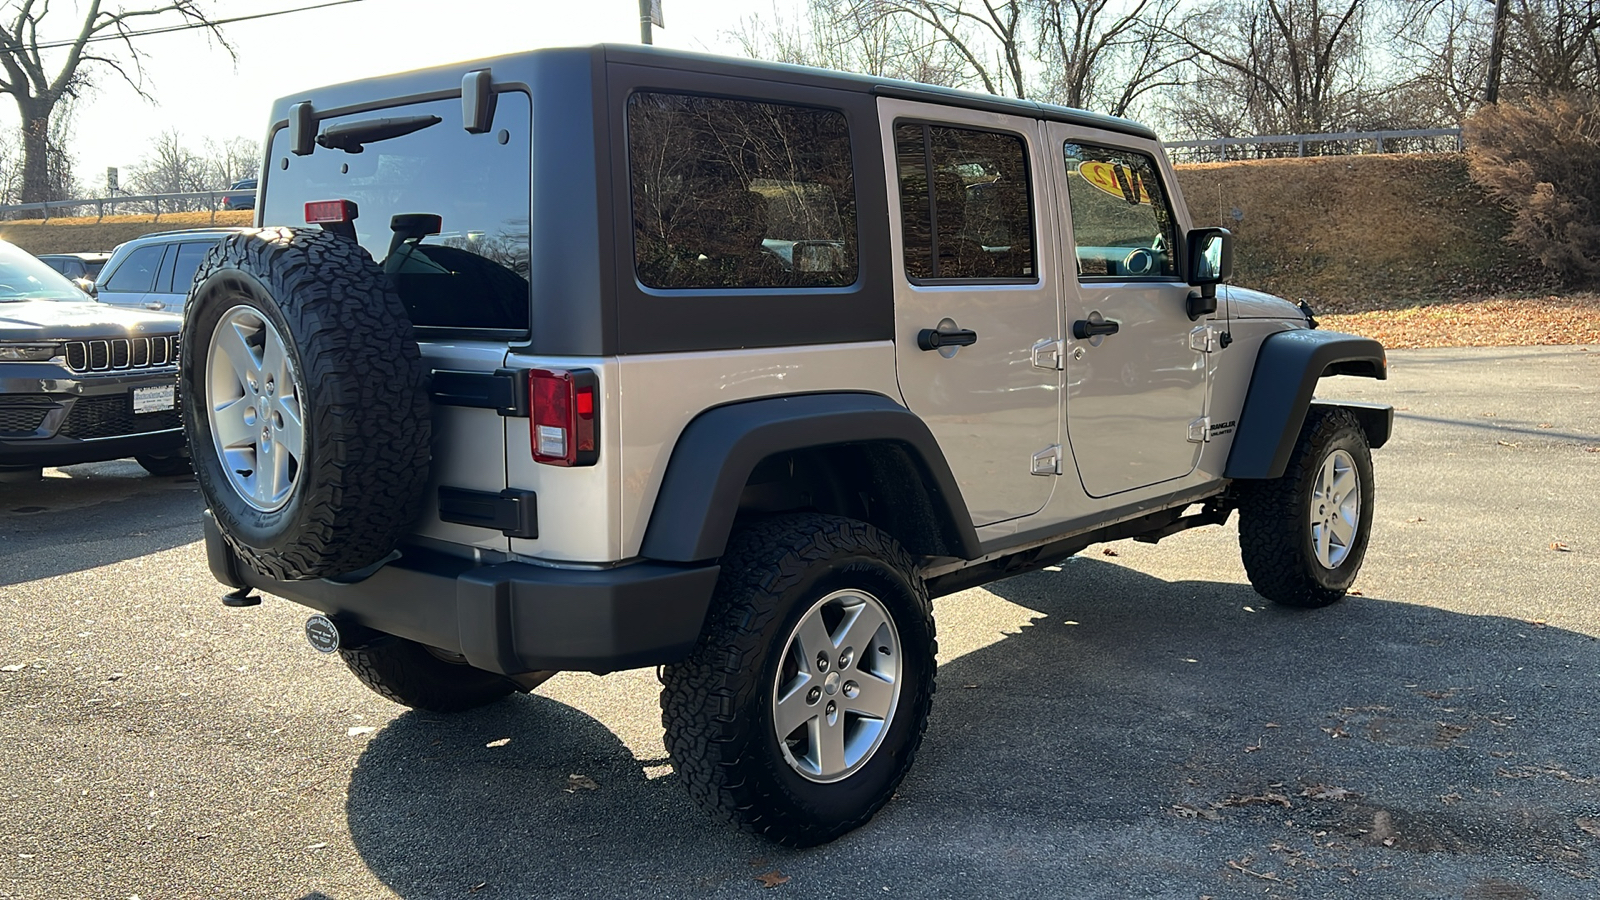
773, 591, 901, 783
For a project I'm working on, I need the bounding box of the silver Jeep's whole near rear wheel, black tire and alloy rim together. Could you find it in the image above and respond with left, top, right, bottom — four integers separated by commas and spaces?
661, 514, 936, 847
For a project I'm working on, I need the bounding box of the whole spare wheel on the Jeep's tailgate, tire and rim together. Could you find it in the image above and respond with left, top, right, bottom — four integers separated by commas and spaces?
179, 227, 430, 580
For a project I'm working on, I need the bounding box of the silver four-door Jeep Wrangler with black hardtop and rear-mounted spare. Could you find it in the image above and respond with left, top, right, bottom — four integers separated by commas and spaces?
181, 46, 1392, 846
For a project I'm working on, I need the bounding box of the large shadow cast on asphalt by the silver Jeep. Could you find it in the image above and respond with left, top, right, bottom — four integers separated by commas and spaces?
347, 557, 1600, 900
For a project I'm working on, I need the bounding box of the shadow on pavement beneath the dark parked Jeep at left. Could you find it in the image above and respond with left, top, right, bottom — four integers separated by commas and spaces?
0, 460, 203, 586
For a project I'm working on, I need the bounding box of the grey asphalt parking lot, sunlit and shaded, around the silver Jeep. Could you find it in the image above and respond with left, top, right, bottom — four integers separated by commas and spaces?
0, 348, 1600, 900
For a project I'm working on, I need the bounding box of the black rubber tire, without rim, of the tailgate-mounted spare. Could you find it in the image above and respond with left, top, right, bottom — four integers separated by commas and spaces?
179, 227, 432, 581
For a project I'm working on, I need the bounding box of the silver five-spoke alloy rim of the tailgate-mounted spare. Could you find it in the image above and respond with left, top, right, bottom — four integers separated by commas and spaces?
205, 306, 306, 512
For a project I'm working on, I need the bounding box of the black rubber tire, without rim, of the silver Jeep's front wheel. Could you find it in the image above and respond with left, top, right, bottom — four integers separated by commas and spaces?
1238, 407, 1373, 609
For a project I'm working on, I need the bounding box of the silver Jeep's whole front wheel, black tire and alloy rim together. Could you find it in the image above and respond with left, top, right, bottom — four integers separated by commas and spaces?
1238, 407, 1373, 609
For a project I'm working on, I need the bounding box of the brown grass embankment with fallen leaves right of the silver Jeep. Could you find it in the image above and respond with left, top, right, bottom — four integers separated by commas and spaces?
1178, 154, 1600, 348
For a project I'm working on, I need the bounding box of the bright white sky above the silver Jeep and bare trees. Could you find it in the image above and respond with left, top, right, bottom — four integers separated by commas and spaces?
0, 0, 774, 195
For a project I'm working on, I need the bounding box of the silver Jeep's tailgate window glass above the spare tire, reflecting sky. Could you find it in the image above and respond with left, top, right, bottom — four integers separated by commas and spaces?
262, 91, 531, 331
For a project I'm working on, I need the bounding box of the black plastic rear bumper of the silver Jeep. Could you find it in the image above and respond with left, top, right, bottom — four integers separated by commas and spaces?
205, 512, 718, 674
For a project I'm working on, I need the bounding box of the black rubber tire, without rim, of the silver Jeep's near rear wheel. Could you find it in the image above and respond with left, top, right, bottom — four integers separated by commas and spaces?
661, 514, 938, 847
